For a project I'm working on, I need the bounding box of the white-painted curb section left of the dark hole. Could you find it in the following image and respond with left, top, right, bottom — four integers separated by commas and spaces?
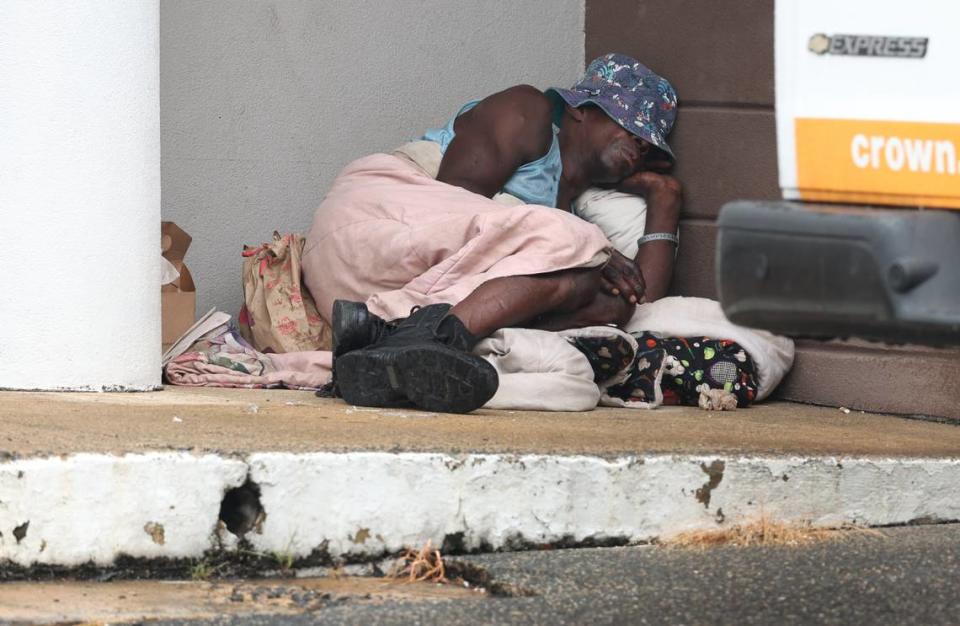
0, 452, 247, 565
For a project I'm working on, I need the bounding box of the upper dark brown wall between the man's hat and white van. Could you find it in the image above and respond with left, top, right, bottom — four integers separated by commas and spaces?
585, 0, 780, 298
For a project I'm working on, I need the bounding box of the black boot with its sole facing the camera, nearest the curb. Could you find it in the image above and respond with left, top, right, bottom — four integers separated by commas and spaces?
336, 304, 499, 413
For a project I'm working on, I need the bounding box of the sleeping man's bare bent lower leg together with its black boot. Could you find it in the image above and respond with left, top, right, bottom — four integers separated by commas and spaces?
334, 269, 633, 413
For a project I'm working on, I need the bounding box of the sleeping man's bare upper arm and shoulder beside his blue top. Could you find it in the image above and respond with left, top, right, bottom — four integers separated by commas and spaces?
437, 85, 553, 198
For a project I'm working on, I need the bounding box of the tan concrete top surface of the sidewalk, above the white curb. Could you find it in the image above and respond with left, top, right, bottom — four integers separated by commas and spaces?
7, 387, 960, 458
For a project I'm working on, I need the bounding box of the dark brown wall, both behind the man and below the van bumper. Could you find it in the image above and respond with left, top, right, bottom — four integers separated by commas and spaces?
585, 0, 960, 419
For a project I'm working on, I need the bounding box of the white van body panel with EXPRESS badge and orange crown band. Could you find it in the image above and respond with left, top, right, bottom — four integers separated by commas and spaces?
775, 0, 960, 208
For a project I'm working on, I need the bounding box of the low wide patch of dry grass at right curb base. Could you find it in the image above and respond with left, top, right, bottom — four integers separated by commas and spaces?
660, 516, 886, 550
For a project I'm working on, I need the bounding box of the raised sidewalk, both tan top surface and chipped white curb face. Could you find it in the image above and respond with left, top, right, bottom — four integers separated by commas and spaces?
0, 388, 960, 566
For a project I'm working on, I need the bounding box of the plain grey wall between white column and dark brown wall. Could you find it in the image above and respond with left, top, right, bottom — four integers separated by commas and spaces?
160, 0, 584, 314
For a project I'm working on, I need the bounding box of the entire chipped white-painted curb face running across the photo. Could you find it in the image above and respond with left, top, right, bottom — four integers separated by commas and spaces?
0, 452, 960, 565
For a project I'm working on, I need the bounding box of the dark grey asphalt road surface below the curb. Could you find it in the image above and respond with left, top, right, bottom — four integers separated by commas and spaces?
152, 525, 960, 626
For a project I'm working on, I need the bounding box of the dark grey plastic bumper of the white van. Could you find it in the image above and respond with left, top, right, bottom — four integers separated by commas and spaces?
716, 201, 960, 345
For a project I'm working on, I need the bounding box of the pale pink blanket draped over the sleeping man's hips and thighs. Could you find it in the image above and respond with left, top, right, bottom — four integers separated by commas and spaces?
303, 149, 610, 321
